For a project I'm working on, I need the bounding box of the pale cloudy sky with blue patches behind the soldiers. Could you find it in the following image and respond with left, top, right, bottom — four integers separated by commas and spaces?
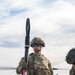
0, 0, 75, 74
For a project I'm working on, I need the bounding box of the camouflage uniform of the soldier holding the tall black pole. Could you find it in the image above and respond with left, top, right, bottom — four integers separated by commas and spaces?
16, 53, 53, 75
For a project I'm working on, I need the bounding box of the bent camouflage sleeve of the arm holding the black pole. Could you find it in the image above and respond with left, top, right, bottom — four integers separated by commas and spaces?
16, 57, 27, 74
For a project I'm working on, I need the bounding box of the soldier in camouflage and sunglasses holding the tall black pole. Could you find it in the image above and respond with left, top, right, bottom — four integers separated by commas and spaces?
16, 37, 53, 75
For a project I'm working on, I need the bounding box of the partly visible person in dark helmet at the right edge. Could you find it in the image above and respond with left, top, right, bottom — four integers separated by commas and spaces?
66, 48, 75, 75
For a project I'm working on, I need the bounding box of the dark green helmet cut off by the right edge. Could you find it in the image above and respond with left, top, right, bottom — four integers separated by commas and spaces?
66, 48, 75, 64
